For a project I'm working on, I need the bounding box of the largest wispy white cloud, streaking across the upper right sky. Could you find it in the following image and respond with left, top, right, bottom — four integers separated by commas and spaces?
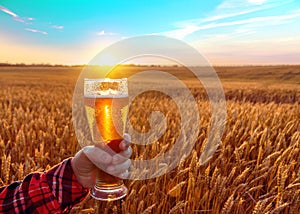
156, 0, 300, 39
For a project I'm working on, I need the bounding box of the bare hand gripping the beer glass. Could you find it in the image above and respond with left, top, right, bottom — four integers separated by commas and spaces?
71, 134, 132, 188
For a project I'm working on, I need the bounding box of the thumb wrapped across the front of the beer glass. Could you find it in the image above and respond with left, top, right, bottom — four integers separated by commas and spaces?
83, 146, 112, 168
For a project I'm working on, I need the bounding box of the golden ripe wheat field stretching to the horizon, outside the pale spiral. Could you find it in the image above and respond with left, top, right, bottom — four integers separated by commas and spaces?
0, 66, 300, 214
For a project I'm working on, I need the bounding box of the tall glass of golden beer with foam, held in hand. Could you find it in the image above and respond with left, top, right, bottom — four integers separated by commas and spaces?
84, 78, 128, 201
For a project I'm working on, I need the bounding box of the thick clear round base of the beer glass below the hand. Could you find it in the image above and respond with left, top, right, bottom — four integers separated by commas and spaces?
91, 184, 128, 201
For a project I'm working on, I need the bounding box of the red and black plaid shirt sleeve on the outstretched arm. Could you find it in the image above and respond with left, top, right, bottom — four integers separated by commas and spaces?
0, 158, 89, 213
